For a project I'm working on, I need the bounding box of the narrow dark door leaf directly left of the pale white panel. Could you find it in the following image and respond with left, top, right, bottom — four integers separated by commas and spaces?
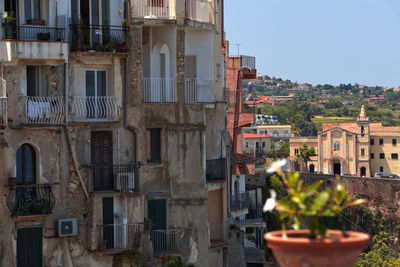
103, 197, 114, 248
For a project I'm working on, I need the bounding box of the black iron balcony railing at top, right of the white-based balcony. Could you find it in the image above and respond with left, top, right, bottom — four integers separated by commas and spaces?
70, 24, 131, 53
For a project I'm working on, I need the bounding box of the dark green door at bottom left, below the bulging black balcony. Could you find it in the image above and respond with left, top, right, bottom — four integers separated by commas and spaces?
17, 227, 43, 267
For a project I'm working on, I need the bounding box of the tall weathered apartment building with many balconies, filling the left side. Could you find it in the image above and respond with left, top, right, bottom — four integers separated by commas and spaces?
0, 0, 229, 267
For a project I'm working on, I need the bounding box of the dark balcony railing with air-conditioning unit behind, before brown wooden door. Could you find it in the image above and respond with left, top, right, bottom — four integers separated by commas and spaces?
92, 165, 139, 192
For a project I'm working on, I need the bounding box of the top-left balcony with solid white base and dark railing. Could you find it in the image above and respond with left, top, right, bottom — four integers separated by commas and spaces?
3, 25, 68, 62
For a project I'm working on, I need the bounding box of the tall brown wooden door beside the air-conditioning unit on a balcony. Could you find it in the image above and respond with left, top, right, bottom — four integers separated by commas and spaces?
91, 132, 114, 191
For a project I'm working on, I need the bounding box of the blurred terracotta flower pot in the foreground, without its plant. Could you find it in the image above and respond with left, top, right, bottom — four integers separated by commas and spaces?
264, 230, 369, 267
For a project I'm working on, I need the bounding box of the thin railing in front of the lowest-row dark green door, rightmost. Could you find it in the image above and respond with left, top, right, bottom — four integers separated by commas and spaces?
150, 227, 185, 253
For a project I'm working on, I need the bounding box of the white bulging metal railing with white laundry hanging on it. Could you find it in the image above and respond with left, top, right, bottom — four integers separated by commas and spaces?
25, 96, 65, 125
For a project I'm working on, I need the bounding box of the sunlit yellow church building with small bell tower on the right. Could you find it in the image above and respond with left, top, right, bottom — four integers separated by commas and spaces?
290, 106, 400, 177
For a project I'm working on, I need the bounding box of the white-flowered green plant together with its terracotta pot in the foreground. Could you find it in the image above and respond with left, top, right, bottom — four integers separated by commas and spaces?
264, 161, 369, 267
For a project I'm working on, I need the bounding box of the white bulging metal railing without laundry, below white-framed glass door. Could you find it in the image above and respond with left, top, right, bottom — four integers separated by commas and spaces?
72, 96, 122, 122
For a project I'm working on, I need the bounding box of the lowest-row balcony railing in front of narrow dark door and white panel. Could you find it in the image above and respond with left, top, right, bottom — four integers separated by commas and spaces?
97, 223, 144, 249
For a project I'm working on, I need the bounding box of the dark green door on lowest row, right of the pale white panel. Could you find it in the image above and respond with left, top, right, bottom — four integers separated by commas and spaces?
147, 199, 168, 253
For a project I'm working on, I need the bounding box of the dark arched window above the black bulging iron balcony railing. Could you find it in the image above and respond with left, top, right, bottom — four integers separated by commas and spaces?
17, 144, 36, 185
